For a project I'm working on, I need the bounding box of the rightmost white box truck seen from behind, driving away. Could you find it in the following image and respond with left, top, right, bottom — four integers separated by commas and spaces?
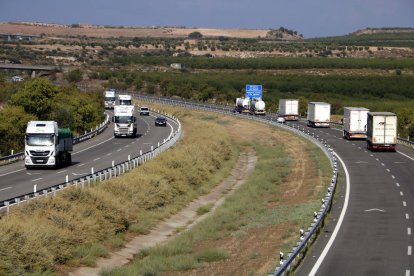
367, 112, 397, 151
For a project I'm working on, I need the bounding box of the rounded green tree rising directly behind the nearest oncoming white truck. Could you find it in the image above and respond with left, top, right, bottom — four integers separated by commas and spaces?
10, 78, 59, 120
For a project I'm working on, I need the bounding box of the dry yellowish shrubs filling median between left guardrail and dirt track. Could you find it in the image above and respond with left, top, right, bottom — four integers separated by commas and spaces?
0, 105, 238, 275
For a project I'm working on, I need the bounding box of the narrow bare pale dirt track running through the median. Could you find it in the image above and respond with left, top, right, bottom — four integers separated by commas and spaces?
69, 150, 257, 276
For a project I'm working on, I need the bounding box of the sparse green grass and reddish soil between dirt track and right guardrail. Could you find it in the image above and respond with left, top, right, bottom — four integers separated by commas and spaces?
103, 106, 331, 276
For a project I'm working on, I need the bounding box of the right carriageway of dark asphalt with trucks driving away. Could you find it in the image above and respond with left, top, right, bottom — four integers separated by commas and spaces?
290, 123, 414, 275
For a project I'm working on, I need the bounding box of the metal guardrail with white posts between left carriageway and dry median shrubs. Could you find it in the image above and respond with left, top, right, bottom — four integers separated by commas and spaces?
0, 110, 182, 214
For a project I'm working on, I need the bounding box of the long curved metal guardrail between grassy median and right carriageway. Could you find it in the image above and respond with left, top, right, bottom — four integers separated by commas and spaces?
128, 92, 338, 275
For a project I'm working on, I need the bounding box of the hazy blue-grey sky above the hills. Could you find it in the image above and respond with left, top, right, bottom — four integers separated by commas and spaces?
0, 0, 414, 38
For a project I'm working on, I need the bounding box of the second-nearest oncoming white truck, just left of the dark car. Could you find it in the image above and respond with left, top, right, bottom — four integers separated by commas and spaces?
113, 105, 137, 137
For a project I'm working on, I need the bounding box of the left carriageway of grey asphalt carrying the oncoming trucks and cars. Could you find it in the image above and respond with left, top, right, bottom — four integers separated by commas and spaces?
0, 112, 178, 203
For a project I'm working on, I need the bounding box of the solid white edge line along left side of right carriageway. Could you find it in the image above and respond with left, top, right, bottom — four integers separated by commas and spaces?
309, 152, 351, 276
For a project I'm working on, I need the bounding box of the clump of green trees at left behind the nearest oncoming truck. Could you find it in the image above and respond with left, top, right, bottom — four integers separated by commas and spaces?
0, 78, 104, 156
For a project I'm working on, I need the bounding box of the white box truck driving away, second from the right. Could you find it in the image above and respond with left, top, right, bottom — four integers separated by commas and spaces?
343, 107, 369, 140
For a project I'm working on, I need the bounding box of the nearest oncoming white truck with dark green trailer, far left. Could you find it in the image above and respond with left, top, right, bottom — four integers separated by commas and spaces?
24, 121, 73, 169
